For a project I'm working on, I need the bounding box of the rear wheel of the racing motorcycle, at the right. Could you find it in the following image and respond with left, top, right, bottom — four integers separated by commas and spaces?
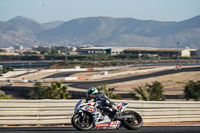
122, 111, 143, 130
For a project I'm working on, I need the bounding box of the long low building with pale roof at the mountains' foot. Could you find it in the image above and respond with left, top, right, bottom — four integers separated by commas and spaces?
78, 46, 198, 57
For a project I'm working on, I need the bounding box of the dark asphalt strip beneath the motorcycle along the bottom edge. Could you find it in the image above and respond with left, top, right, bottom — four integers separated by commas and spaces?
0, 126, 200, 133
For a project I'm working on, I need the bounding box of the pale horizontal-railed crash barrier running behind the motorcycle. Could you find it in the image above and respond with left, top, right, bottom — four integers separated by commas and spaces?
0, 99, 200, 125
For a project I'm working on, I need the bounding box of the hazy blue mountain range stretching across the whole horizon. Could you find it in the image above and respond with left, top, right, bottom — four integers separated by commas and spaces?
0, 15, 200, 48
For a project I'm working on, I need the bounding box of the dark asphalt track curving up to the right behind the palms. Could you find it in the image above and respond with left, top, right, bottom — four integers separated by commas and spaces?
66, 67, 200, 89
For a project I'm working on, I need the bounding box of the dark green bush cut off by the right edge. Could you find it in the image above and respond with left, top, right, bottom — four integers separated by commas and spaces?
184, 80, 200, 101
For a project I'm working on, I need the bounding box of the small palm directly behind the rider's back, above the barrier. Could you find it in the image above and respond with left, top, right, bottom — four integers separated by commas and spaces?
96, 85, 120, 99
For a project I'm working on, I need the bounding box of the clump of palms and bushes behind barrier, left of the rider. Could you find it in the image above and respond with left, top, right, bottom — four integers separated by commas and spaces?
28, 82, 71, 99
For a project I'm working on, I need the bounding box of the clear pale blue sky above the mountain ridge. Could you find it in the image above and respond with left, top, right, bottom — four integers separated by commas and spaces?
0, 0, 200, 23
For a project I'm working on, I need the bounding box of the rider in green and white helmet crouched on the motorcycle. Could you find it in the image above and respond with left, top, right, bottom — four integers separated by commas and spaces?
86, 87, 120, 118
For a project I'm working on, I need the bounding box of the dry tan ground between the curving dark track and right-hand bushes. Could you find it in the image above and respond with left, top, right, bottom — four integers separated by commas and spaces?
109, 71, 200, 95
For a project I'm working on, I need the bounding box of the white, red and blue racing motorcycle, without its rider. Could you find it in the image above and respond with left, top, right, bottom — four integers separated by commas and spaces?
71, 99, 143, 131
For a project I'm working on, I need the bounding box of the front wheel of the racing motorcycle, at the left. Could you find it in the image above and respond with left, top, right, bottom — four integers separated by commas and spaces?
71, 113, 93, 131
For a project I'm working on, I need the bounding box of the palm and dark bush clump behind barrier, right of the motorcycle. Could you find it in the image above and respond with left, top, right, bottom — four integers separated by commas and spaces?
133, 81, 165, 101
